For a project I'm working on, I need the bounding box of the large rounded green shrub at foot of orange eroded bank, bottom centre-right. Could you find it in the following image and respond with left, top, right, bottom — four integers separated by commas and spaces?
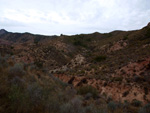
77, 85, 98, 98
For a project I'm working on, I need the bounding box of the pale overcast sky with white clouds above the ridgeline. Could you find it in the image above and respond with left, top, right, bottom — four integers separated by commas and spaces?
0, 0, 150, 35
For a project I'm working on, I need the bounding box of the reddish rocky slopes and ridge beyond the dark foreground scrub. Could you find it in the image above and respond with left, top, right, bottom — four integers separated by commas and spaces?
0, 24, 150, 103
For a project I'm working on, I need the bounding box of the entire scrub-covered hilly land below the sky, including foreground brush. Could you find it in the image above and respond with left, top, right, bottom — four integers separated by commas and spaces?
0, 24, 150, 113
